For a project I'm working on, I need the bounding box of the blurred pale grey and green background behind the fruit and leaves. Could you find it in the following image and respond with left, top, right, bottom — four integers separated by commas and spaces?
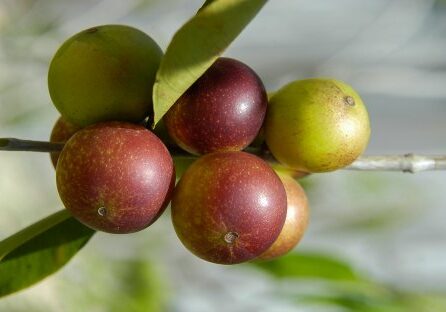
0, 0, 446, 312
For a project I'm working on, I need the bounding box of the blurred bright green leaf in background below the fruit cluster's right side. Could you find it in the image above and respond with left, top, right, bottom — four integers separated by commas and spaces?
253, 253, 359, 281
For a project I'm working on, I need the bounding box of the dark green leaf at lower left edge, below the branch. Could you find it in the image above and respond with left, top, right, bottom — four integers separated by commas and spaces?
0, 210, 94, 297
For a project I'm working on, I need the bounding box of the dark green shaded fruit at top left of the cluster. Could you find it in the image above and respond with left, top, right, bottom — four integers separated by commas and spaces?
48, 25, 163, 126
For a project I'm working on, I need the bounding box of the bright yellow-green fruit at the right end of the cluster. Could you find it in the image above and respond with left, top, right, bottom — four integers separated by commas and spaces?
265, 79, 370, 172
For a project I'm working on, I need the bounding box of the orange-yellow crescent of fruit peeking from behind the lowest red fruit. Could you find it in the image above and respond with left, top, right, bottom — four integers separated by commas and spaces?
258, 174, 309, 260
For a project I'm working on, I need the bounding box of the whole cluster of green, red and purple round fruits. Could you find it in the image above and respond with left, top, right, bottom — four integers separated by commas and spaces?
48, 25, 370, 264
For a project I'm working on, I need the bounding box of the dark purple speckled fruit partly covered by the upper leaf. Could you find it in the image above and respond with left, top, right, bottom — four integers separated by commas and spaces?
164, 58, 267, 155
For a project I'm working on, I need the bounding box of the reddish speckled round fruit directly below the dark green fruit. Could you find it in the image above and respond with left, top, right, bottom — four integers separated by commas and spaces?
56, 122, 175, 233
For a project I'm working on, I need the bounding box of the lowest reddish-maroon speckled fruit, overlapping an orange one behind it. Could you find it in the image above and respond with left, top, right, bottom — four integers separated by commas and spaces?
171, 152, 287, 264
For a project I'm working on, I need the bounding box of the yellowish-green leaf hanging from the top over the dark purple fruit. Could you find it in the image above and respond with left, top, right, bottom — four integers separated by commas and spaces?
153, 0, 267, 124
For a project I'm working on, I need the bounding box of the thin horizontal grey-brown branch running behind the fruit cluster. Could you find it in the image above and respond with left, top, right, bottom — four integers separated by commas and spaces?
0, 138, 446, 173
